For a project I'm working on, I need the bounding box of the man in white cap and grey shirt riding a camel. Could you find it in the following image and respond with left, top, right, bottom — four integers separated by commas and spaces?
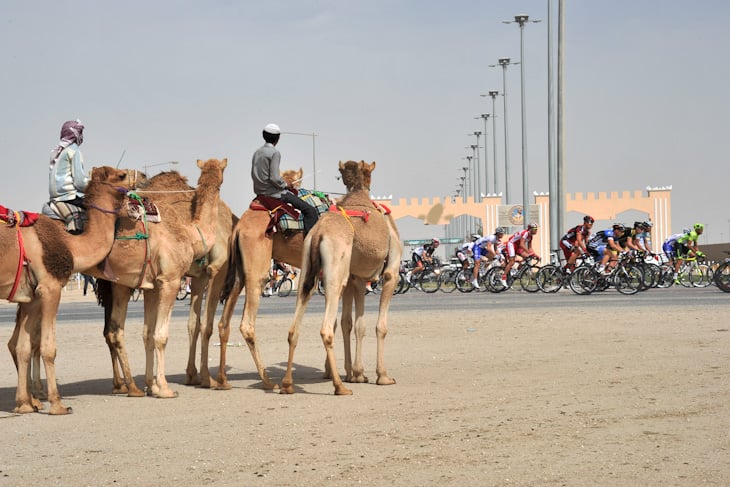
251, 123, 319, 236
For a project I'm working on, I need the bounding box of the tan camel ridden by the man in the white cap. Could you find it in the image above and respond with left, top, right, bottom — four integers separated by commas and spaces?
217, 168, 312, 390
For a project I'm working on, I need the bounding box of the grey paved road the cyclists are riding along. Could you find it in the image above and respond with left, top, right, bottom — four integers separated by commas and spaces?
0, 286, 730, 334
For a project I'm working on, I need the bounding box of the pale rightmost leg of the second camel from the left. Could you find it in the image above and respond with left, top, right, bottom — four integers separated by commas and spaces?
144, 277, 180, 398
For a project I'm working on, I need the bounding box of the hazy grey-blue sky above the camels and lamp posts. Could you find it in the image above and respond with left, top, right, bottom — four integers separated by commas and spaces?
0, 0, 730, 243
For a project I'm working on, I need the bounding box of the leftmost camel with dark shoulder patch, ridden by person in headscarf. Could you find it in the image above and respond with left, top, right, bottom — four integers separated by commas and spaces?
0, 167, 129, 415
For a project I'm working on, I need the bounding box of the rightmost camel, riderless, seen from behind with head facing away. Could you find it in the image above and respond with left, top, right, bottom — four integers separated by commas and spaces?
281, 161, 403, 395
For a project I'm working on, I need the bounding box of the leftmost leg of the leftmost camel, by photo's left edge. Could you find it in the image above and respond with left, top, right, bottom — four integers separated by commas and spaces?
8, 303, 38, 414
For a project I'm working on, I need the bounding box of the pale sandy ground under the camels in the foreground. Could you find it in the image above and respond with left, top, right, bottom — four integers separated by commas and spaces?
0, 293, 730, 486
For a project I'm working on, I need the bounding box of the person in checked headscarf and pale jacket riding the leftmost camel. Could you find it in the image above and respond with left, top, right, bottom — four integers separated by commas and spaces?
44, 120, 89, 233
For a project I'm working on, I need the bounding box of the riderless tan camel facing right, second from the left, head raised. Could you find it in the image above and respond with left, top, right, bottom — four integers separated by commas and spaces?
85, 159, 228, 398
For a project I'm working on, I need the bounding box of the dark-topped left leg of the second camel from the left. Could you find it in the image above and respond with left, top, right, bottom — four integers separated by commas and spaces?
104, 283, 144, 397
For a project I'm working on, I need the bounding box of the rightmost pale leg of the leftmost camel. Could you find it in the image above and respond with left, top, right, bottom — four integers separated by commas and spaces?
36, 288, 72, 415
